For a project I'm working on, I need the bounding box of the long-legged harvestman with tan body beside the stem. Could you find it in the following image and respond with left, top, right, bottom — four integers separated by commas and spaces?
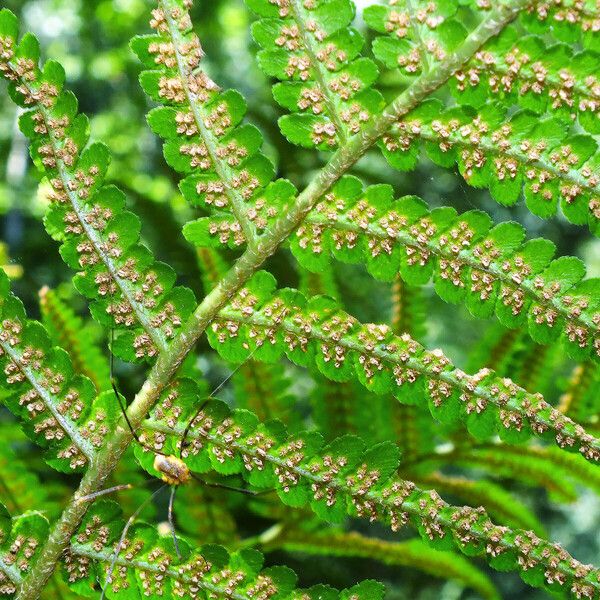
79, 330, 271, 600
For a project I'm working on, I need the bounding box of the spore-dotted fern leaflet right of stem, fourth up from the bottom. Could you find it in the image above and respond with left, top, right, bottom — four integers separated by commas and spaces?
282, 177, 600, 359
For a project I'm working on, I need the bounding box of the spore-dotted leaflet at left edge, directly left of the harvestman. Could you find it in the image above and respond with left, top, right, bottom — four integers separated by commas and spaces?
0, 271, 117, 472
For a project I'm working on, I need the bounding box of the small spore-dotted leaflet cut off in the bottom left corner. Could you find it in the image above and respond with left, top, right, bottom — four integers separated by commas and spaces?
0, 504, 48, 598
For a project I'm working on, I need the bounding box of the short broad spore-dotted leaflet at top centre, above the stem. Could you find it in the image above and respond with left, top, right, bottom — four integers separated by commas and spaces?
246, 0, 384, 150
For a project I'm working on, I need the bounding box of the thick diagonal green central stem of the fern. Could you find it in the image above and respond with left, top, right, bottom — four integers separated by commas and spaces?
18, 0, 531, 600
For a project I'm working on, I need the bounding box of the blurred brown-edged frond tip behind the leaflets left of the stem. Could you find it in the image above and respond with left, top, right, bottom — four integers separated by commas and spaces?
40, 287, 111, 391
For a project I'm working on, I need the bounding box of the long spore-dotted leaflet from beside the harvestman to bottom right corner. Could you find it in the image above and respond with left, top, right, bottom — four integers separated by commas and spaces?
139, 392, 600, 596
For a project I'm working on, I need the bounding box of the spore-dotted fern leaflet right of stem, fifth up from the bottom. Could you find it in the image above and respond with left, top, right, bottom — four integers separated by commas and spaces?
380, 100, 600, 234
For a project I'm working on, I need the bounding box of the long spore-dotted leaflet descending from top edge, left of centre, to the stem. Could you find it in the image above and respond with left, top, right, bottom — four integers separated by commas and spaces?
132, 0, 295, 247
